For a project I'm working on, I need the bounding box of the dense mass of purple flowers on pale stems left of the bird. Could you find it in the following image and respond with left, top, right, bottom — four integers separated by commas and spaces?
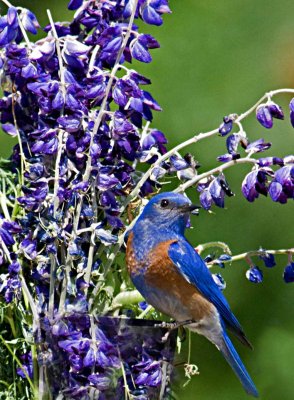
0, 0, 175, 398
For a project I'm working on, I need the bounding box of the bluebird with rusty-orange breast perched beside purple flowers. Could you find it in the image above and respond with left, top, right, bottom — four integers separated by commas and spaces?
126, 192, 258, 397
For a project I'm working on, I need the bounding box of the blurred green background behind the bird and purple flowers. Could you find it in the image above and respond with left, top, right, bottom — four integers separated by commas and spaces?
0, 0, 294, 400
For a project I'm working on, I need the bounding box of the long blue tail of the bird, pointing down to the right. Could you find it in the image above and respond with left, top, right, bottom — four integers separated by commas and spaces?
220, 331, 258, 397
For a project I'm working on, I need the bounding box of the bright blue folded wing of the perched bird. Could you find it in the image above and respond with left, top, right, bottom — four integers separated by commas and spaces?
168, 240, 251, 347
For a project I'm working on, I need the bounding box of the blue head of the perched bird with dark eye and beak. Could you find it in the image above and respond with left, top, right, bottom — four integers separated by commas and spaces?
139, 192, 200, 234
